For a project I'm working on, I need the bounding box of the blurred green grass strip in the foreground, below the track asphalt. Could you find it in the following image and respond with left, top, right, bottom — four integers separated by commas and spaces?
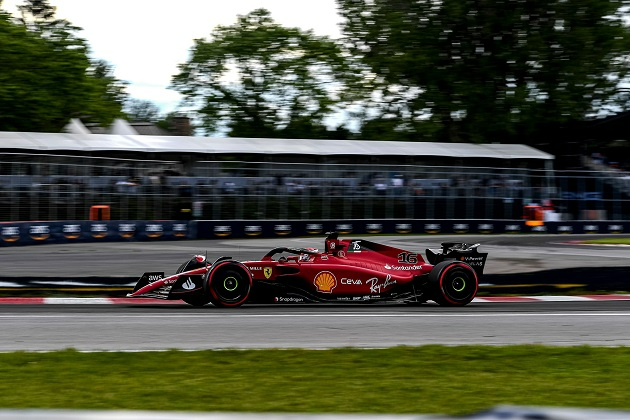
0, 343, 630, 415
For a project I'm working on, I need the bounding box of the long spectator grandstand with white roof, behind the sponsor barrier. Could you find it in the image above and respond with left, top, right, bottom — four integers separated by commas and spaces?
0, 128, 630, 221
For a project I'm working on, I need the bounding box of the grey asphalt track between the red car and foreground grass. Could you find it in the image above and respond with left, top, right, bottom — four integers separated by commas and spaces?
0, 300, 630, 351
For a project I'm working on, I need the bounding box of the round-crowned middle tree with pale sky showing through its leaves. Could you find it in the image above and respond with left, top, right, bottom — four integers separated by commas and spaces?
172, 9, 348, 138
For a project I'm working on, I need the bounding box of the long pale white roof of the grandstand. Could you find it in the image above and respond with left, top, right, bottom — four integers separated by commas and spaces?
0, 132, 554, 160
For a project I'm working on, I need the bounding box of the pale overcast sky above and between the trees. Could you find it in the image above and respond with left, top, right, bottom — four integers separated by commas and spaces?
2, 0, 341, 113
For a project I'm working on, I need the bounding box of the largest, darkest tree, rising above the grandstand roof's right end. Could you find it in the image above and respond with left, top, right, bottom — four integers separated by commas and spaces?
338, 0, 629, 142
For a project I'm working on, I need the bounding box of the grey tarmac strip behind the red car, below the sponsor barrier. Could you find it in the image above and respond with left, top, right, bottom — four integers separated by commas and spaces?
0, 234, 630, 279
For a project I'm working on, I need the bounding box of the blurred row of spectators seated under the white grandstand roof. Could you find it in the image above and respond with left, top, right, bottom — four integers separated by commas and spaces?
0, 170, 544, 198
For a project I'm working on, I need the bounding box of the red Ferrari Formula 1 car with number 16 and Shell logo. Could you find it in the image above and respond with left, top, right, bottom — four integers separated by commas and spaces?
127, 232, 488, 307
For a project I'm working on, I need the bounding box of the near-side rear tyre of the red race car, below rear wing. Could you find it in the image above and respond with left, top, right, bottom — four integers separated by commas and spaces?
429, 261, 479, 306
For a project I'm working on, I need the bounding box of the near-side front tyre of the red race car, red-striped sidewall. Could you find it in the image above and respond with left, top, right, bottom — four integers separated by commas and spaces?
204, 261, 252, 307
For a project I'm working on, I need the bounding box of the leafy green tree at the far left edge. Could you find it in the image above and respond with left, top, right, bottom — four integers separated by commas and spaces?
0, 0, 126, 132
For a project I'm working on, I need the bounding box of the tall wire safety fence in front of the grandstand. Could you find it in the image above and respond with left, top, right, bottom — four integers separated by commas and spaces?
0, 153, 630, 221
